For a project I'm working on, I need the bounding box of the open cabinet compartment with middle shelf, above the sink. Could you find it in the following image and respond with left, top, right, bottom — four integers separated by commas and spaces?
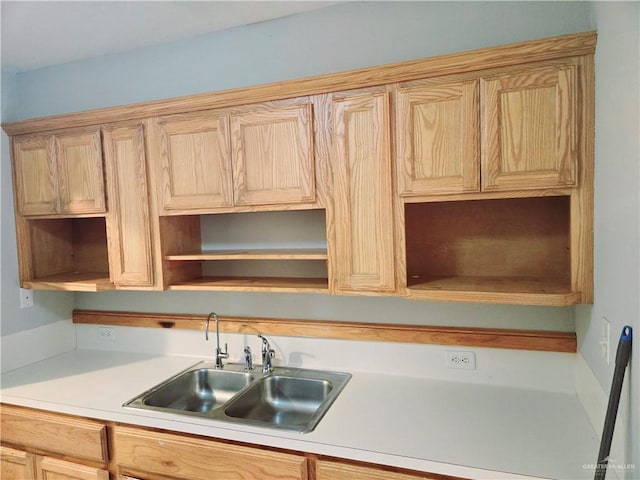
160, 210, 329, 293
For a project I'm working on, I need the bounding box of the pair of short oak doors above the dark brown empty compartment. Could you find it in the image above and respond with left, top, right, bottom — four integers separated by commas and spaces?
396, 65, 577, 196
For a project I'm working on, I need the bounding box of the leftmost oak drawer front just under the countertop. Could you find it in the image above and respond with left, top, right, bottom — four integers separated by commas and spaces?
0, 405, 109, 462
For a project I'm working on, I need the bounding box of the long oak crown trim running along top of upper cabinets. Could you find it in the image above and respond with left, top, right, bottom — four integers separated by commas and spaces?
2, 32, 596, 135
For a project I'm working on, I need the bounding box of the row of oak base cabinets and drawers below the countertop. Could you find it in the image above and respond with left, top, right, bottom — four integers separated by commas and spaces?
0, 405, 462, 480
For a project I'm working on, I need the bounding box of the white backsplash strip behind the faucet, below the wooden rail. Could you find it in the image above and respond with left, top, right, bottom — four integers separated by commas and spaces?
76, 324, 575, 393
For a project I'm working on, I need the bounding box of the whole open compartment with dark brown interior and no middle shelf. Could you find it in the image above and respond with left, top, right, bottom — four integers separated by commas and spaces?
405, 196, 579, 305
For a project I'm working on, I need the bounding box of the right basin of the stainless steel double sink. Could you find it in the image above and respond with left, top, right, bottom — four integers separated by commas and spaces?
224, 370, 350, 432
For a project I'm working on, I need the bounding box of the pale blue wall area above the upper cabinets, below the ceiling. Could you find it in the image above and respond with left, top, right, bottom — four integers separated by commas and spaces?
12, 1, 594, 119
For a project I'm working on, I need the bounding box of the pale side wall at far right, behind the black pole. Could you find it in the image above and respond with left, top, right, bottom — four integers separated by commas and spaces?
576, 2, 640, 472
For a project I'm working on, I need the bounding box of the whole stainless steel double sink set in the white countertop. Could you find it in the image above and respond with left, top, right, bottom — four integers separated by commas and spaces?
123, 361, 351, 433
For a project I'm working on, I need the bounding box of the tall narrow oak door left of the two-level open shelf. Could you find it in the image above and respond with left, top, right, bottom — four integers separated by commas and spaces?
104, 125, 153, 286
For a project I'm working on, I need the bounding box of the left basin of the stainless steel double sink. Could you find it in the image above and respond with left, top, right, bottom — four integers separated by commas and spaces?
125, 362, 255, 413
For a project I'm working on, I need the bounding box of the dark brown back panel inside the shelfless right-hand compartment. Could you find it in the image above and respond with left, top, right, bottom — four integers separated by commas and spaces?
405, 197, 571, 280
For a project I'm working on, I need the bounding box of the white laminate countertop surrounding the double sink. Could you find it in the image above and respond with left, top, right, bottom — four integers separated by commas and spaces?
0, 349, 598, 480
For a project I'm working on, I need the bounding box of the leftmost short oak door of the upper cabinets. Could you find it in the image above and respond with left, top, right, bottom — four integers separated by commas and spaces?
13, 135, 59, 215
